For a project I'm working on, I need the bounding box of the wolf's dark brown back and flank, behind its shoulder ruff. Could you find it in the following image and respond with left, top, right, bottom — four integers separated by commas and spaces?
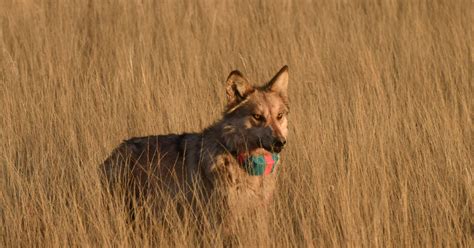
100, 133, 196, 195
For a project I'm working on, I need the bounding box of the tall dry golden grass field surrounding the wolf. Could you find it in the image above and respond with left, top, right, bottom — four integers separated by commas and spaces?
0, 0, 474, 247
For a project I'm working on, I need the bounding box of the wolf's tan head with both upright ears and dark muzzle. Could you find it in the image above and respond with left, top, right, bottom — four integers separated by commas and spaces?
219, 66, 289, 153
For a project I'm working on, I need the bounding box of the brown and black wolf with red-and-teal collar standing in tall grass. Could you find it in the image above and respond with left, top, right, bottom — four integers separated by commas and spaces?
101, 66, 289, 232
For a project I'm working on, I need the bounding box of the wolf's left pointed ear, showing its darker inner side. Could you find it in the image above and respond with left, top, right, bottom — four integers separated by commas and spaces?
226, 70, 255, 107
